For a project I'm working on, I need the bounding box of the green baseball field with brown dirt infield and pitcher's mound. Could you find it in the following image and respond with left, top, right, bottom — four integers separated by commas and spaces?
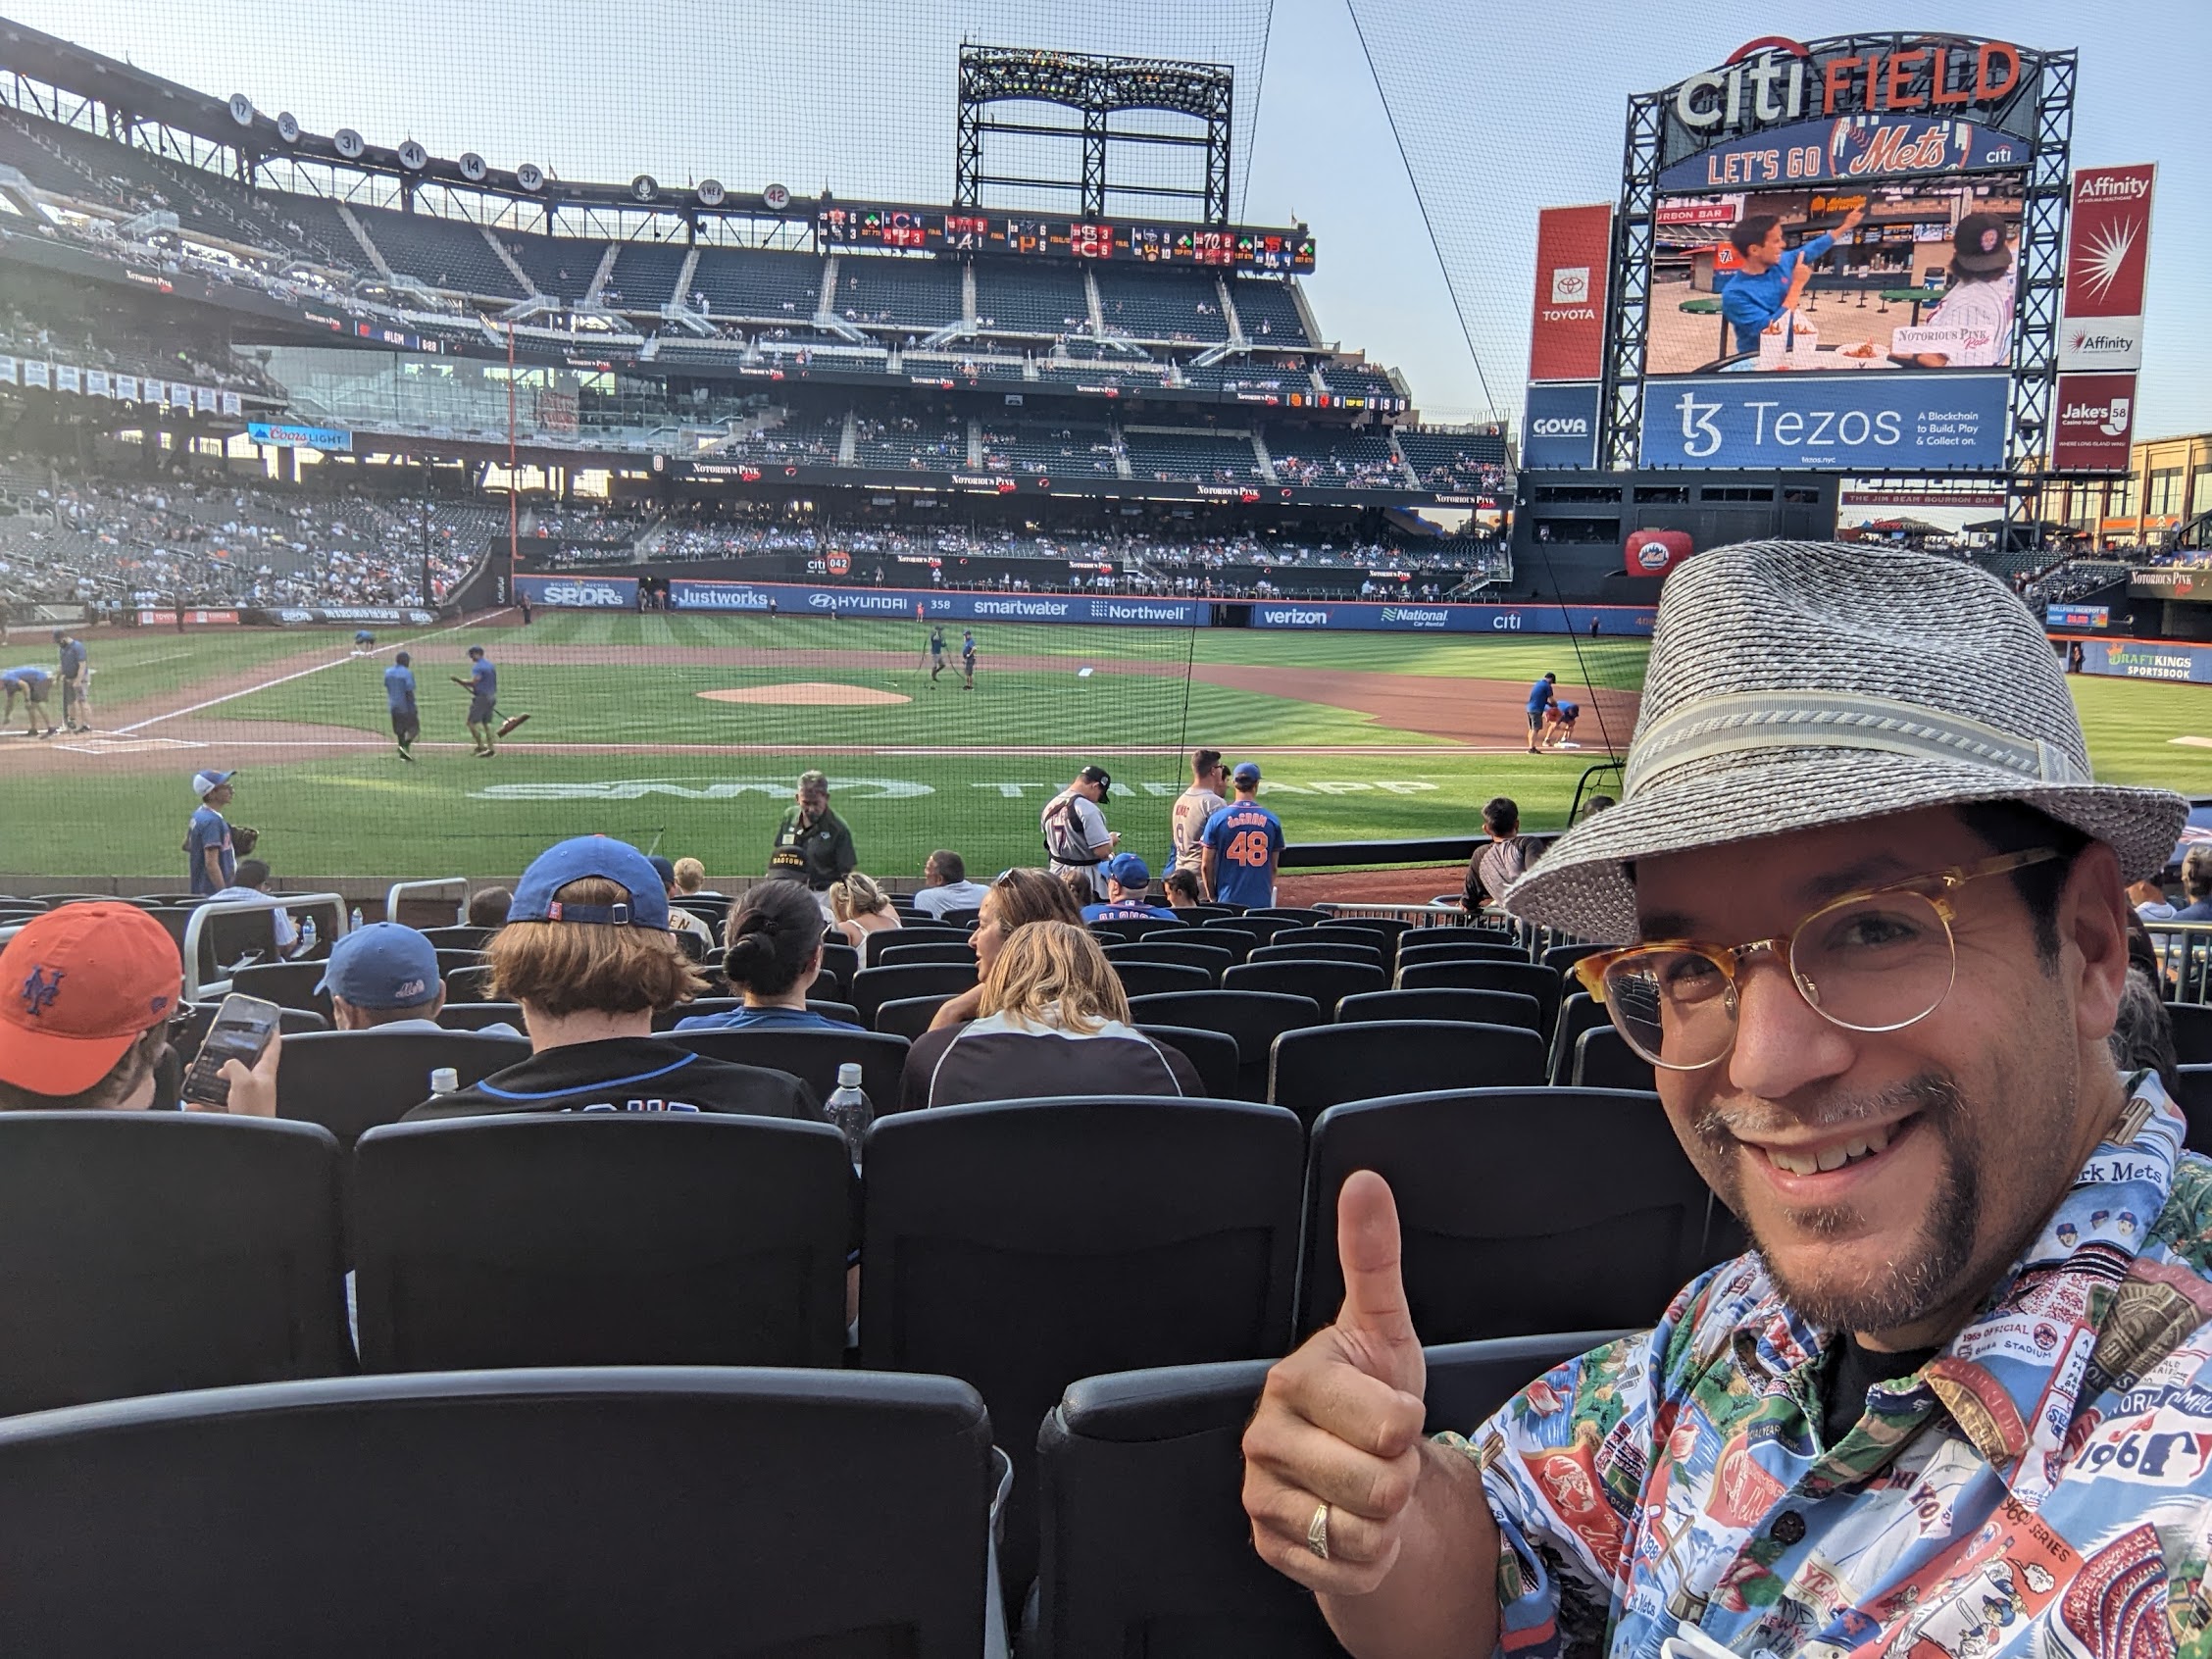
0, 613, 2212, 884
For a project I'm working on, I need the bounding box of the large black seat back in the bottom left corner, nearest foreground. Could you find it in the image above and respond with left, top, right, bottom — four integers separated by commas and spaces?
0, 1367, 997, 1659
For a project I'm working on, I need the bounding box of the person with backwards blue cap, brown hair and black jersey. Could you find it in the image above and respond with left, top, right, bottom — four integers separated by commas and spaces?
405, 836, 823, 1124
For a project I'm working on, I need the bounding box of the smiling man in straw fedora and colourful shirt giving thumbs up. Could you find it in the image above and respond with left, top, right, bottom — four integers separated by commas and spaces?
1245, 542, 2212, 1659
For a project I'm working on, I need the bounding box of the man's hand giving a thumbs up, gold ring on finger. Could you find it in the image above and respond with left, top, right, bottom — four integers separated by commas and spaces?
1243, 1170, 1427, 1595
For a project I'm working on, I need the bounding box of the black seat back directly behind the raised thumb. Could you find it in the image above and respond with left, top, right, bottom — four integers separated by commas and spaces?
1298, 1088, 1726, 1342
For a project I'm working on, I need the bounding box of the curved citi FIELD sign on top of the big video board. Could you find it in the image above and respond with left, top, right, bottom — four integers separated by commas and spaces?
1654, 33, 2041, 171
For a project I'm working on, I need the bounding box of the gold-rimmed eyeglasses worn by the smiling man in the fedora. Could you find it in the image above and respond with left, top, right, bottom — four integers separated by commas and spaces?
1575, 847, 2059, 1071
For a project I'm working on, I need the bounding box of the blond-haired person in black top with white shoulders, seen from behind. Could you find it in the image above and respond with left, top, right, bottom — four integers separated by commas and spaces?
898, 923, 1206, 1111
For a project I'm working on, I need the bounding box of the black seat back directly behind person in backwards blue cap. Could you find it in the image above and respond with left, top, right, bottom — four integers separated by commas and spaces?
354, 1113, 854, 1372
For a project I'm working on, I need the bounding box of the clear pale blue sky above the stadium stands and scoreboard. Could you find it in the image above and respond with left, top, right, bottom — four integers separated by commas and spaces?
21, 0, 2212, 435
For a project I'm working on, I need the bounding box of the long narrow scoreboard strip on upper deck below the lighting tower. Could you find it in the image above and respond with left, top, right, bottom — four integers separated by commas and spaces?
814, 206, 1314, 272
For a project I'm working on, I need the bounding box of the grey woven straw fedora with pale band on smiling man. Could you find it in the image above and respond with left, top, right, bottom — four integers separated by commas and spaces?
1504, 542, 2187, 944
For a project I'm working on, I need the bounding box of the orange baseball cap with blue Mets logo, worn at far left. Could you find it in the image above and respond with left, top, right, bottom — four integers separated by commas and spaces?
0, 902, 183, 1095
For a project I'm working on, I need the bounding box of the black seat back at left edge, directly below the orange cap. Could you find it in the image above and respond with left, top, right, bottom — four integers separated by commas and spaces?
0, 1113, 352, 1415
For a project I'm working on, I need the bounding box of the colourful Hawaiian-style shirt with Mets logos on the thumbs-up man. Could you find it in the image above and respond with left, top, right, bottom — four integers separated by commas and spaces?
1451, 1073, 2212, 1659
